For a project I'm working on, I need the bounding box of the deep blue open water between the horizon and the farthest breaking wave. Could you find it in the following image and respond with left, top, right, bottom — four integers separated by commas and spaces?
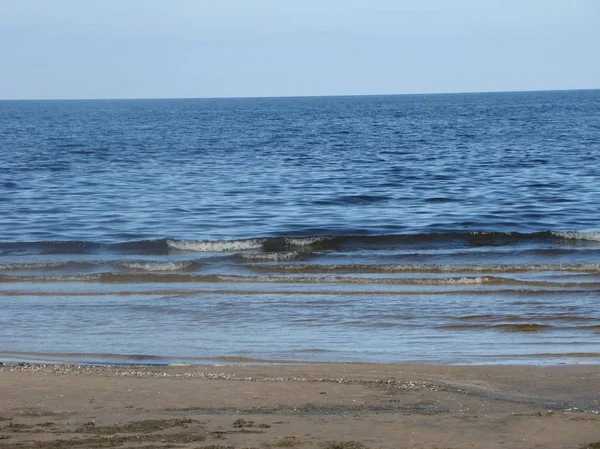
0, 91, 600, 242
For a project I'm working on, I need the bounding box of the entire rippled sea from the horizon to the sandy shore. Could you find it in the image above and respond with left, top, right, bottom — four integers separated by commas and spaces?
0, 90, 600, 365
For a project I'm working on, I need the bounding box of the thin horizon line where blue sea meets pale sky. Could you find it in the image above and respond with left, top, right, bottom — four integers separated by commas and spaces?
0, 87, 600, 101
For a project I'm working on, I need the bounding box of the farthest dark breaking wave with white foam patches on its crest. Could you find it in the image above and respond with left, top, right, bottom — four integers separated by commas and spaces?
0, 230, 600, 255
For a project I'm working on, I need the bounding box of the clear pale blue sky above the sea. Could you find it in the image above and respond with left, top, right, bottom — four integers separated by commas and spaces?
0, 0, 600, 99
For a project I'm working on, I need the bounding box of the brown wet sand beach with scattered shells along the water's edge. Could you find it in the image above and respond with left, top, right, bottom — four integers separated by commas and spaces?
0, 364, 600, 449
